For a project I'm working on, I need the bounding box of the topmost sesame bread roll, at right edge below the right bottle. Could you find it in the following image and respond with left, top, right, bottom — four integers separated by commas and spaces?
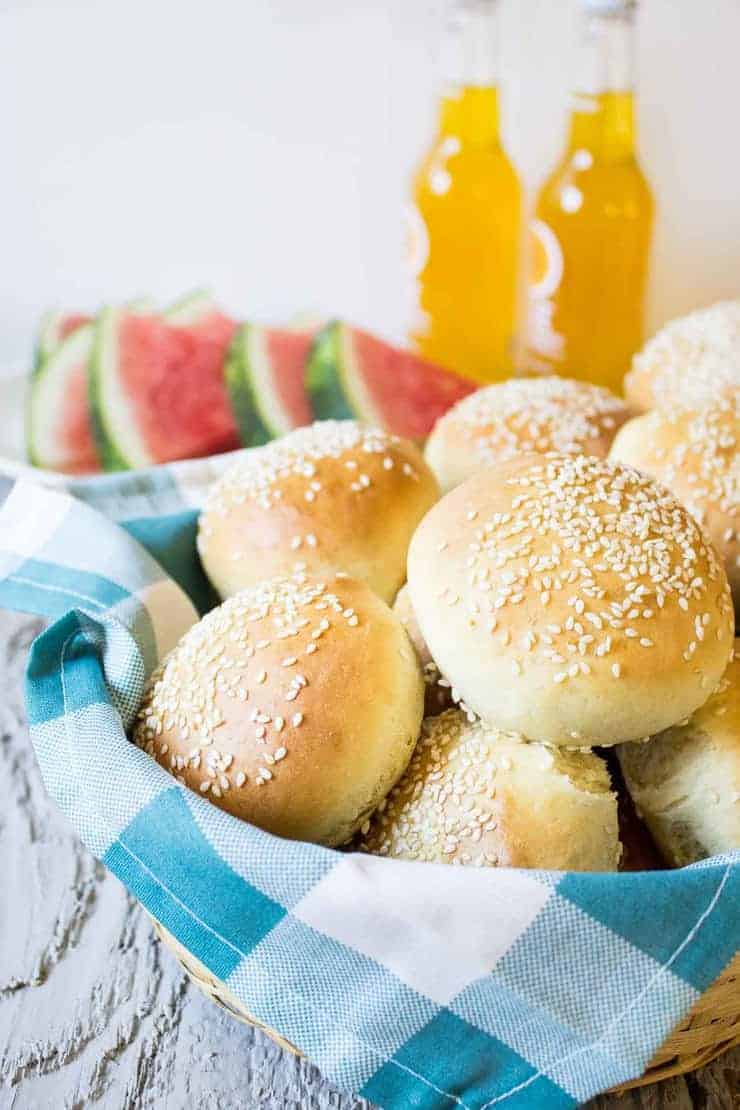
625, 301, 740, 412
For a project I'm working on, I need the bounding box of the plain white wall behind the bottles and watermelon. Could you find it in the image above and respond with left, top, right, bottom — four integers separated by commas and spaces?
0, 0, 740, 363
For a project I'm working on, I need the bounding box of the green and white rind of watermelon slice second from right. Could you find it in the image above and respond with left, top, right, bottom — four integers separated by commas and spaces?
225, 324, 306, 447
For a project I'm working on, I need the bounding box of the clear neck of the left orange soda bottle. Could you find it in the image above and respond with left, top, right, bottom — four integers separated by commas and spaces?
439, 0, 499, 147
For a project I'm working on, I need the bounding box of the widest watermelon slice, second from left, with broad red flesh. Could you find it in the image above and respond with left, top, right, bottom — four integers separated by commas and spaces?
89, 302, 240, 470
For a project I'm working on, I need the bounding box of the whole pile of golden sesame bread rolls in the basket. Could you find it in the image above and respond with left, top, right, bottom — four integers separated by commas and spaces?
133, 305, 740, 870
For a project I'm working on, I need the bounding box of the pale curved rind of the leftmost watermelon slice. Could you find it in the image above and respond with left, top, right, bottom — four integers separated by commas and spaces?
26, 324, 94, 470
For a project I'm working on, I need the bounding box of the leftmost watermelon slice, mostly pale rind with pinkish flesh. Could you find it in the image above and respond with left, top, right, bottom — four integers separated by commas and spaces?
27, 323, 100, 474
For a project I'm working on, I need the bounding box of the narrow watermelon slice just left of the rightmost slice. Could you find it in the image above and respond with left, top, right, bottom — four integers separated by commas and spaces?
225, 324, 313, 447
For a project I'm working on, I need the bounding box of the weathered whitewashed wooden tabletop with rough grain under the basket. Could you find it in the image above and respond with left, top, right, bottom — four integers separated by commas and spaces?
0, 612, 740, 1110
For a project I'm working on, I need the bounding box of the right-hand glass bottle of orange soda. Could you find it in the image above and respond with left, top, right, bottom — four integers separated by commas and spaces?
524, 0, 653, 392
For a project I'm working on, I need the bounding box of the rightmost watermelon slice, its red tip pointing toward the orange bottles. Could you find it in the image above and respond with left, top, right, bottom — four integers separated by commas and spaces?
306, 321, 478, 440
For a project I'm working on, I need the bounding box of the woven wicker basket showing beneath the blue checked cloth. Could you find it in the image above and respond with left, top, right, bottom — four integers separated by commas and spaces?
154, 920, 740, 1091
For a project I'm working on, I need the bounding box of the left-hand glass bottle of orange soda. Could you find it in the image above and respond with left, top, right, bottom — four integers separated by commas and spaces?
409, 0, 521, 382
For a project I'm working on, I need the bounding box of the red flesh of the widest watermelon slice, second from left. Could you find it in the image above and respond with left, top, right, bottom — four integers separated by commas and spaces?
119, 313, 240, 463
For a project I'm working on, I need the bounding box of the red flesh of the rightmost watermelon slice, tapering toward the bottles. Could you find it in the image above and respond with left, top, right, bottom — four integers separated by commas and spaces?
348, 327, 479, 440
